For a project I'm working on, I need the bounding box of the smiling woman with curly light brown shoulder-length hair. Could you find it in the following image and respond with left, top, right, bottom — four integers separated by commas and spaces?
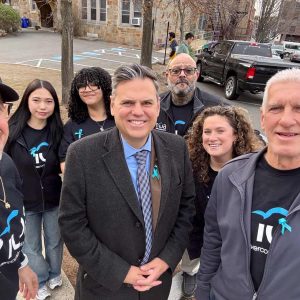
181, 106, 263, 298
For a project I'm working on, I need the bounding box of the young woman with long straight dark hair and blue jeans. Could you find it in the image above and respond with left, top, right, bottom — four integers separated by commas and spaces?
6, 79, 63, 300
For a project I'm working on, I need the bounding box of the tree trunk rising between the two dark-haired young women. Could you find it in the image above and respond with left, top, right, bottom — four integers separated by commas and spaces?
60, 0, 74, 104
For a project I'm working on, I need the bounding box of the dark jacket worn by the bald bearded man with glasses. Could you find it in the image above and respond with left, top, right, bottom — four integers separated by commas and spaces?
155, 87, 228, 135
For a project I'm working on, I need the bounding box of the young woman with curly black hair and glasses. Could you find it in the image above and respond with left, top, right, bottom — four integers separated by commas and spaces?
59, 67, 115, 171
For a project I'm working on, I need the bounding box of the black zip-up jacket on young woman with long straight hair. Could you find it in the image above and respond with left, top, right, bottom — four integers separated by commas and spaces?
7, 135, 61, 212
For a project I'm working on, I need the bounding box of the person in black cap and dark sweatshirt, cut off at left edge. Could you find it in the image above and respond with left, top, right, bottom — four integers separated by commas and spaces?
0, 80, 38, 300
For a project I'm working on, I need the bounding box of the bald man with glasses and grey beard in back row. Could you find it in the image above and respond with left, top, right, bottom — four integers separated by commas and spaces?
156, 53, 222, 136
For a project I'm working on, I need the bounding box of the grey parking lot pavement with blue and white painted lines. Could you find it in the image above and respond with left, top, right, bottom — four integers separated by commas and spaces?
0, 30, 164, 74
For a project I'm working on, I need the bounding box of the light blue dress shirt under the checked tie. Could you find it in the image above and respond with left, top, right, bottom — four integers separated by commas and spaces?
121, 133, 152, 196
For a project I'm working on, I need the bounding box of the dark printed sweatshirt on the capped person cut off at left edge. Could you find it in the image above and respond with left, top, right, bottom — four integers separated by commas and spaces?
0, 153, 25, 300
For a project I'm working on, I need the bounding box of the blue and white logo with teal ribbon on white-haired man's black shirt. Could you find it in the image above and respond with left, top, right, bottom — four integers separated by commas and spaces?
252, 207, 292, 243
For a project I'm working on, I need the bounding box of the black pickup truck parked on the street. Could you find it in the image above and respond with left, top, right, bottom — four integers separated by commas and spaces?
197, 41, 299, 99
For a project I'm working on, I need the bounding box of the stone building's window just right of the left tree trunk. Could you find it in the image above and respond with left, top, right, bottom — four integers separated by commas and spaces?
81, 0, 107, 23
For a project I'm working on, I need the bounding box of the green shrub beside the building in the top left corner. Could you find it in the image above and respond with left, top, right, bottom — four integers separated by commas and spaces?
0, 3, 20, 32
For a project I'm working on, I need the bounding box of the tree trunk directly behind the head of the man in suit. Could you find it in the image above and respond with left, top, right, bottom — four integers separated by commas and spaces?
140, 0, 153, 68
